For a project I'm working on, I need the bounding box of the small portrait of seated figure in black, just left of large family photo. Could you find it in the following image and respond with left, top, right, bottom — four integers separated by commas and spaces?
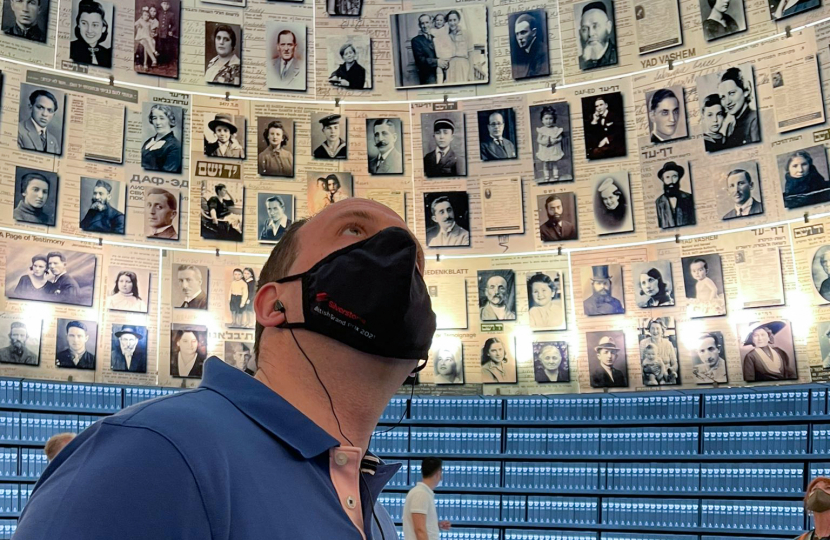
326, 34, 372, 90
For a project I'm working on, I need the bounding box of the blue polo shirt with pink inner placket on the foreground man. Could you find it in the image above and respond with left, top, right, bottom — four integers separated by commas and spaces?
14, 358, 400, 540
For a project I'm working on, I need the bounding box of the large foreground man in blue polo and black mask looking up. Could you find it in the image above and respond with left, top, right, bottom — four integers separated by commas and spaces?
16, 199, 436, 540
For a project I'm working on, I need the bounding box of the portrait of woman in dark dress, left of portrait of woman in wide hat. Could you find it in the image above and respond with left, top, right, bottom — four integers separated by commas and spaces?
141, 101, 184, 173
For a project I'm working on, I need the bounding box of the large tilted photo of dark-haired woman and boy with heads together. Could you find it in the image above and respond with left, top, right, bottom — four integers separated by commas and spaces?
697, 64, 761, 152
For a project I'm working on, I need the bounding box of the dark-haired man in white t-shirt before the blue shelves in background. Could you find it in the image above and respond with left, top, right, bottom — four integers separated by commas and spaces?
403, 457, 450, 540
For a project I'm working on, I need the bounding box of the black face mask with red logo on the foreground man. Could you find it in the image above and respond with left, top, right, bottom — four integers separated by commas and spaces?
277, 227, 436, 360
